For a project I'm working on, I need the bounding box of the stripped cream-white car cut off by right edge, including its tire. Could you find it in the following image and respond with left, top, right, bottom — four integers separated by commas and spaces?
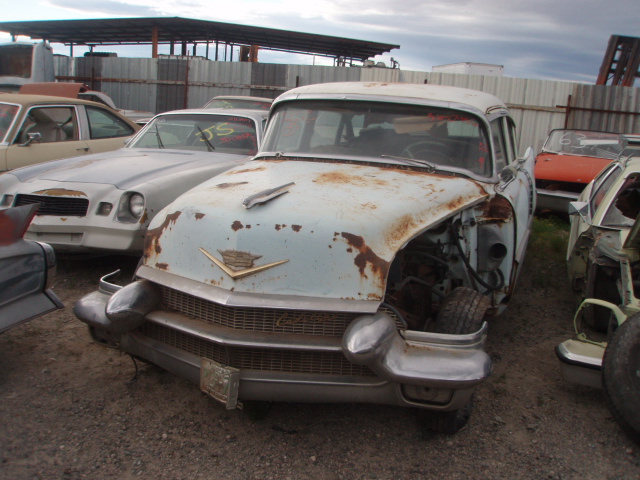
556, 155, 640, 442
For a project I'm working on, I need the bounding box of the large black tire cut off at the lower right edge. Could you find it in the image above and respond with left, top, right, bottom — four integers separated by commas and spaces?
602, 313, 640, 443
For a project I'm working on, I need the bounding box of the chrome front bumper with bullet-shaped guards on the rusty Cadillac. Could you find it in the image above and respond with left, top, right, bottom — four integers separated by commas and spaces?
74, 277, 491, 410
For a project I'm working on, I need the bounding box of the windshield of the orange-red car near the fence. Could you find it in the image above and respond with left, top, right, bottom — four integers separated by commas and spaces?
542, 130, 624, 160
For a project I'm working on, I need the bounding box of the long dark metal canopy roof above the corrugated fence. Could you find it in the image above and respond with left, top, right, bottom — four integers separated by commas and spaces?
0, 17, 400, 61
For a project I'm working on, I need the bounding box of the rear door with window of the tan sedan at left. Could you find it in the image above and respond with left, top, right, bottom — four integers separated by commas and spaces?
82, 105, 136, 153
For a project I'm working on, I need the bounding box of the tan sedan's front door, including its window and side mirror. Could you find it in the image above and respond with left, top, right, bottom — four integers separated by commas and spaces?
6, 105, 89, 170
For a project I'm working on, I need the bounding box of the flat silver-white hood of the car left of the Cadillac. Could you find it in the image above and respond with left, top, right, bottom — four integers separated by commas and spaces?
11, 148, 244, 190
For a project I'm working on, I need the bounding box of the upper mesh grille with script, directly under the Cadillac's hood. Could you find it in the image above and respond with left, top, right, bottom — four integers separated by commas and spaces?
160, 286, 397, 337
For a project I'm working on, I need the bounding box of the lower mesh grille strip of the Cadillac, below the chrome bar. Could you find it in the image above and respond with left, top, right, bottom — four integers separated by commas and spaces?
139, 322, 375, 376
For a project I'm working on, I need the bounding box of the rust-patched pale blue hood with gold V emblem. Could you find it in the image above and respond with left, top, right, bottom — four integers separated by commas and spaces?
145, 160, 489, 302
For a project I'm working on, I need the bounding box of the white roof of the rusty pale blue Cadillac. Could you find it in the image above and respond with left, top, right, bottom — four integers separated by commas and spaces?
274, 82, 506, 114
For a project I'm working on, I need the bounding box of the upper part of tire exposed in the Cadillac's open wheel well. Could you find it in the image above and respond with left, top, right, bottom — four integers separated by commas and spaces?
435, 287, 489, 335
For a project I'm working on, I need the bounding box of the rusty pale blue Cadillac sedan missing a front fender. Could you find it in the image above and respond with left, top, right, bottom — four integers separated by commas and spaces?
74, 83, 535, 433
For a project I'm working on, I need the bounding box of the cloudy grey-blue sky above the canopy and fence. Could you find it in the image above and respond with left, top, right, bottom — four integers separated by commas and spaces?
0, 0, 640, 83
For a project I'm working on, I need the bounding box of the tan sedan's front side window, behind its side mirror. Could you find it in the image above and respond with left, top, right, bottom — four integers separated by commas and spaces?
16, 106, 78, 144
